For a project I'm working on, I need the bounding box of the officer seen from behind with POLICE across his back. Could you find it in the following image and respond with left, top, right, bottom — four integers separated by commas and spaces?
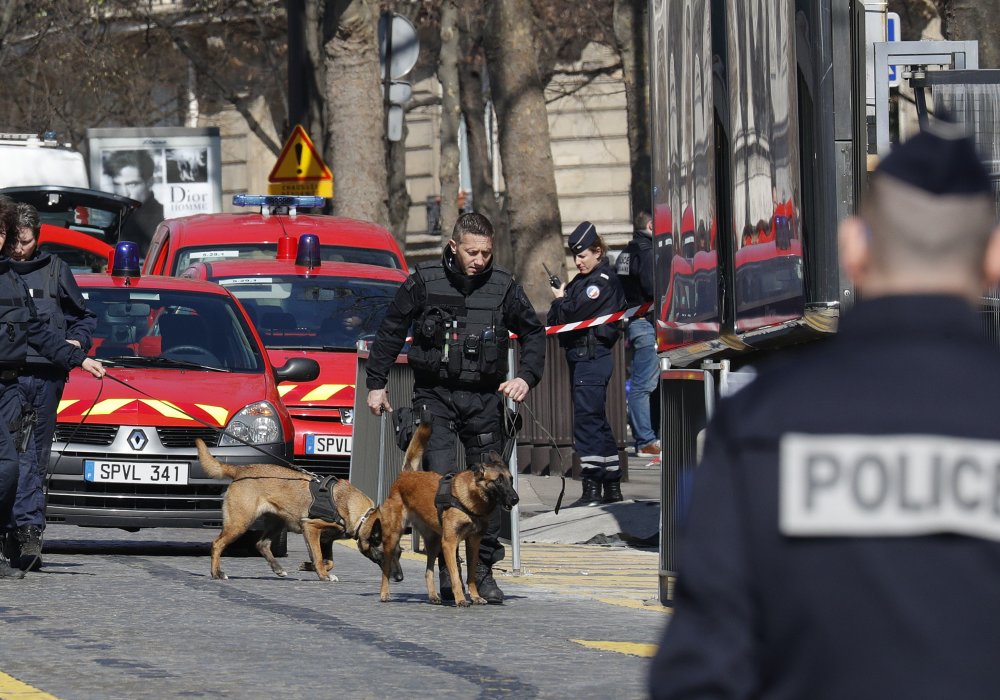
650, 125, 1000, 700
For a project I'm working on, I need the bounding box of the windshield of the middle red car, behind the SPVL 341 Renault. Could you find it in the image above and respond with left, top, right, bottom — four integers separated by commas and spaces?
216, 275, 399, 350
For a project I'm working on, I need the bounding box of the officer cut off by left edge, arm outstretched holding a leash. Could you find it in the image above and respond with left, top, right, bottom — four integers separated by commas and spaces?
0, 197, 104, 579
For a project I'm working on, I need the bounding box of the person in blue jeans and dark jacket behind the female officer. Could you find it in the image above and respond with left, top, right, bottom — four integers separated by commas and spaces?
615, 211, 660, 458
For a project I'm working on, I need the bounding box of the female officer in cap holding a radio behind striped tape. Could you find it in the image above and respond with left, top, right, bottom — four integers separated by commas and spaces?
548, 221, 625, 506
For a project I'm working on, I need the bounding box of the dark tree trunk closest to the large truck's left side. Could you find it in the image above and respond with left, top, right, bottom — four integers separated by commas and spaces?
614, 0, 653, 219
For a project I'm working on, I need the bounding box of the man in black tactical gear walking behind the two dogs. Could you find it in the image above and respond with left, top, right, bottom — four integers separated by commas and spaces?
366, 213, 545, 603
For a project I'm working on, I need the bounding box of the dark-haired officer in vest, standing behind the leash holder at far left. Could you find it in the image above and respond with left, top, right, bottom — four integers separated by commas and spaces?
4, 202, 97, 570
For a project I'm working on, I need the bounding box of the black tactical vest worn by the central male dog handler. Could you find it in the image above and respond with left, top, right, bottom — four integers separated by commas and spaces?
406, 262, 513, 385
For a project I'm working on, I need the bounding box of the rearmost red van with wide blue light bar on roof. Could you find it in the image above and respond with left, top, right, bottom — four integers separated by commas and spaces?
142, 195, 407, 275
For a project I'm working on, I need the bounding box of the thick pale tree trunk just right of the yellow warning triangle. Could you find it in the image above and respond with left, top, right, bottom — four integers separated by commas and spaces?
323, 0, 389, 226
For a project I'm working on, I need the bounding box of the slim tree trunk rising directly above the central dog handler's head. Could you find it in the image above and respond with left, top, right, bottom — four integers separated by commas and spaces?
437, 0, 462, 243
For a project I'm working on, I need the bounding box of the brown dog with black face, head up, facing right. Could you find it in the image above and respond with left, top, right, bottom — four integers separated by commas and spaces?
358, 423, 518, 607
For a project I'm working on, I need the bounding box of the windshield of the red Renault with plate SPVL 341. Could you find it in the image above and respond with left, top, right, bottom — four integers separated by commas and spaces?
82, 287, 266, 373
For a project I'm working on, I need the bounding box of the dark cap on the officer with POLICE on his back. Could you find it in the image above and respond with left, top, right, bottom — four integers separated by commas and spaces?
875, 121, 993, 195
